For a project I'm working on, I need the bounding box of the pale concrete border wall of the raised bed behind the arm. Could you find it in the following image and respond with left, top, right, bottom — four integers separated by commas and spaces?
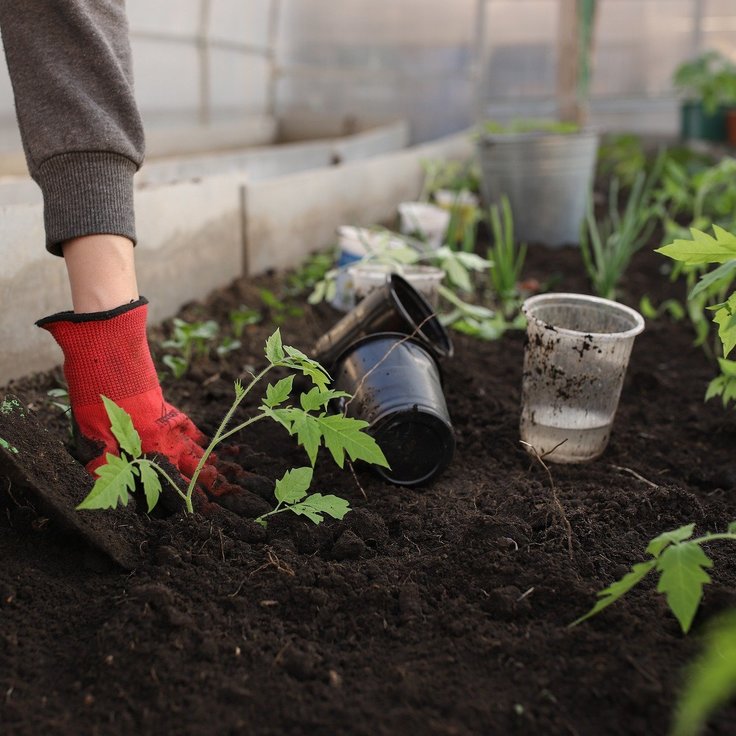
0, 122, 473, 385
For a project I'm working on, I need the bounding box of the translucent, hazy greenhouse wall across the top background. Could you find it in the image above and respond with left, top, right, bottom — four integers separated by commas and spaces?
0, 0, 736, 168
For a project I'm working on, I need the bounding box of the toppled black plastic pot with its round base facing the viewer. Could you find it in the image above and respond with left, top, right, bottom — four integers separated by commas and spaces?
334, 333, 455, 486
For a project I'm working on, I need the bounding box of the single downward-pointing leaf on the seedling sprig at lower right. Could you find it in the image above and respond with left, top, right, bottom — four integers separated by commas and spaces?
657, 542, 713, 634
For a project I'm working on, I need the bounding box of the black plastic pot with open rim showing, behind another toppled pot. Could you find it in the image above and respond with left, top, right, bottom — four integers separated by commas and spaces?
312, 274, 453, 371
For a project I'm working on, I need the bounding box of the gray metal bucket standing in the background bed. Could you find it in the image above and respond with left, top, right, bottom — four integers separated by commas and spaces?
478, 130, 598, 246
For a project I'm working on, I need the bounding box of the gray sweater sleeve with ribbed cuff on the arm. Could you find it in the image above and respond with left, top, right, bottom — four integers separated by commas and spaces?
0, 0, 144, 255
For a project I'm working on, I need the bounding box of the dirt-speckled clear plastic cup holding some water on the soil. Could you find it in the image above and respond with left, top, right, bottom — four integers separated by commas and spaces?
520, 293, 644, 463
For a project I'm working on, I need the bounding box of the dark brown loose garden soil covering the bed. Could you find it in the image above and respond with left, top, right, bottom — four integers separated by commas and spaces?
0, 242, 736, 736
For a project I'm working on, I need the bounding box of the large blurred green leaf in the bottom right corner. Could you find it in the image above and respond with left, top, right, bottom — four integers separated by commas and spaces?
672, 612, 736, 736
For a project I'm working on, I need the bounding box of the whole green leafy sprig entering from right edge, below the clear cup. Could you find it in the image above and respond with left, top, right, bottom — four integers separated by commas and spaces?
570, 522, 736, 633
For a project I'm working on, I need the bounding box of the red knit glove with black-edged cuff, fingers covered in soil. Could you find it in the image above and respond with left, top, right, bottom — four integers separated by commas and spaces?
36, 297, 270, 510
